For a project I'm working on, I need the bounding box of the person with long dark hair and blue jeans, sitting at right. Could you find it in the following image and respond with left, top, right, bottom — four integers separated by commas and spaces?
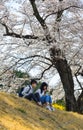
35, 82, 54, 111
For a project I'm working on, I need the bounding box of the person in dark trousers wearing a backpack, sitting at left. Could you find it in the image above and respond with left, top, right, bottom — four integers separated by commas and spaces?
22, 79, 41, 105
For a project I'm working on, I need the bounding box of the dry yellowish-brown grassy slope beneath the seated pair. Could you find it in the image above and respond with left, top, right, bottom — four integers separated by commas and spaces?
0, 93, 83, 130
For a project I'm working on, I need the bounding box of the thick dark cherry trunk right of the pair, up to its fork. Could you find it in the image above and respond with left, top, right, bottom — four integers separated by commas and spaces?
50, 47, 78, 112
